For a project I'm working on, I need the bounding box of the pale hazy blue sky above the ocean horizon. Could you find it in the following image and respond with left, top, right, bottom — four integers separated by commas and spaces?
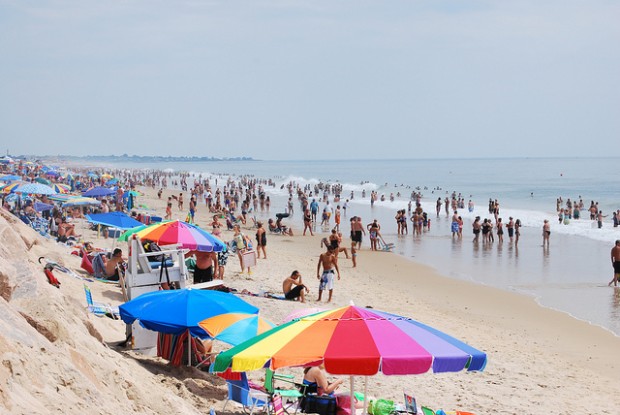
0, 0, 620, 160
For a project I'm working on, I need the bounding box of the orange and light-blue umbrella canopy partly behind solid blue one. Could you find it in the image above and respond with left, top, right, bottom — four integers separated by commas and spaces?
198, 313, 275, 346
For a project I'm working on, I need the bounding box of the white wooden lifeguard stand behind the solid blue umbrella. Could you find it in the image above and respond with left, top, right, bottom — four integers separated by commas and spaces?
125, 237, 187, 356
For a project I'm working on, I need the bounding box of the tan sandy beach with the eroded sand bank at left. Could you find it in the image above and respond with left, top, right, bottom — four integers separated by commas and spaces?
0, 183, 620, 415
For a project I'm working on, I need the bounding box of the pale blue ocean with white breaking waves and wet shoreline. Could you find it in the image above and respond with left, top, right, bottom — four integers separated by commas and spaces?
94, 158, 620, 335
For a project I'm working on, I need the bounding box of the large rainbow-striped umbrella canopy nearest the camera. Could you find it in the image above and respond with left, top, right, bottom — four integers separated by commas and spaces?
213, 306, 487, 376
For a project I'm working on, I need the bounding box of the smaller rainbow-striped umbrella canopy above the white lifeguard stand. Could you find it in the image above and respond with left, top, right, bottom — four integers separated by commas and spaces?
135, 220, 226, 252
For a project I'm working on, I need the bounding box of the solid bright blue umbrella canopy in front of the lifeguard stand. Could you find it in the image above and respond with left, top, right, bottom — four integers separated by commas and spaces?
119, 289, 258, 338
